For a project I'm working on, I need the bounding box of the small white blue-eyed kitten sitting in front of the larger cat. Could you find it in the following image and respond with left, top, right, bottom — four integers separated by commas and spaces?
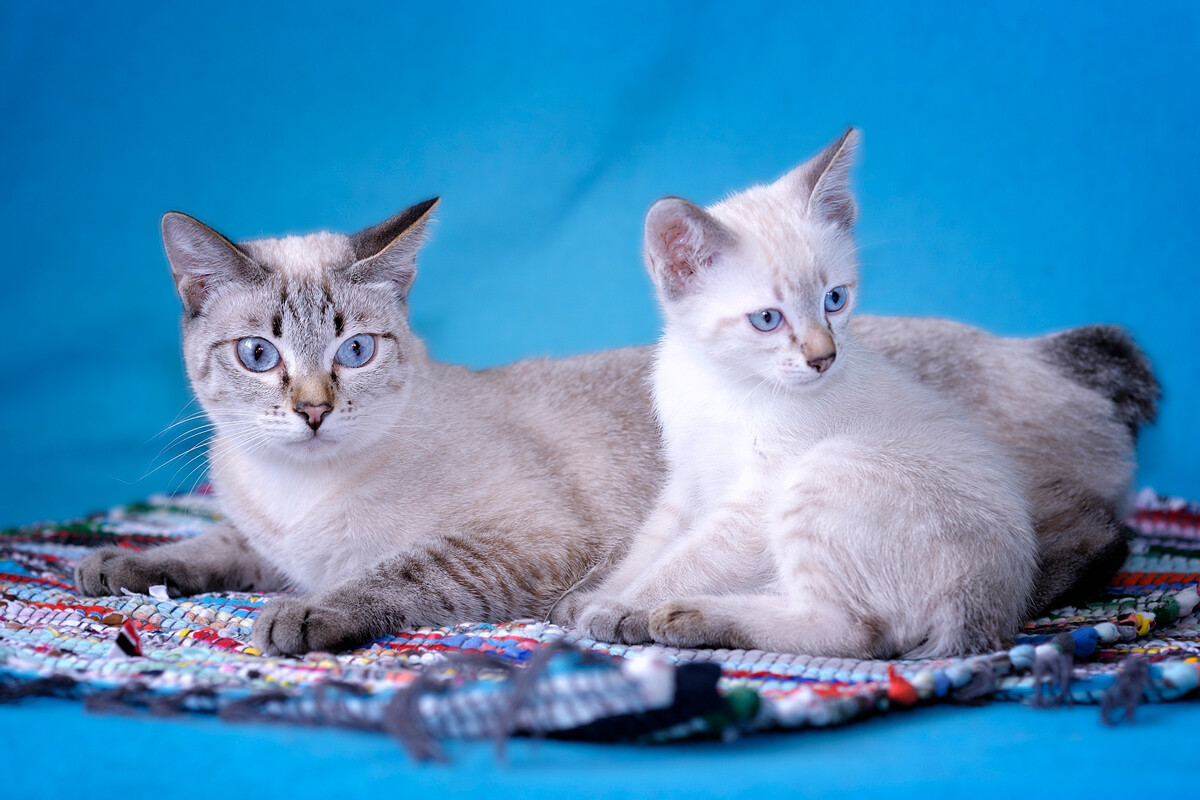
561, 130, 1037, 658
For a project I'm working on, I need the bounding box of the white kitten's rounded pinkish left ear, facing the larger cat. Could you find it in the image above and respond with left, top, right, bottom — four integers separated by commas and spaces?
646, 197, 737, 300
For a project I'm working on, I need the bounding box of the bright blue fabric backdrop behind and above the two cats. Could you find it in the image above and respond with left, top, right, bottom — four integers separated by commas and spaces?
0, 0, 1200, 796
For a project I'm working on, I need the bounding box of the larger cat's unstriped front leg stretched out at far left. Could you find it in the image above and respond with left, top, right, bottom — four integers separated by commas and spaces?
76, 523, 286, 597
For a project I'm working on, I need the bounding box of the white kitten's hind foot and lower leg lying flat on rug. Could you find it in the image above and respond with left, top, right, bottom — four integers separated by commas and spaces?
650, 595, 893, 658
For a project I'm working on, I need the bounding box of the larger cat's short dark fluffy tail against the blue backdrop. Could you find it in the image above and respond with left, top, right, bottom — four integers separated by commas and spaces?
1040, 325, 1162, 439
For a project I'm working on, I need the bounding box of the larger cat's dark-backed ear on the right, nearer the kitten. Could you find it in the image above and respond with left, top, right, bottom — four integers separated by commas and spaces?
346, 198, 439, 299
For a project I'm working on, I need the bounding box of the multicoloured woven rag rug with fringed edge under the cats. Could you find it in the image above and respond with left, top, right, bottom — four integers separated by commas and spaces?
0, 491, 1200, 757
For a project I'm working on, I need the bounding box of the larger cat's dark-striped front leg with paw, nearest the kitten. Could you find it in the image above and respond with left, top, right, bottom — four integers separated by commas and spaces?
253, 530, 578, 654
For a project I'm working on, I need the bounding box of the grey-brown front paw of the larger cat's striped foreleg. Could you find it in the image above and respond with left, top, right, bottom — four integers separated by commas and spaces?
251, 595, 372, 656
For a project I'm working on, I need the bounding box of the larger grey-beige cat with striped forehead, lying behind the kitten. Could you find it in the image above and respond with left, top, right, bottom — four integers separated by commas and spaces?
76, 188, 1157, 654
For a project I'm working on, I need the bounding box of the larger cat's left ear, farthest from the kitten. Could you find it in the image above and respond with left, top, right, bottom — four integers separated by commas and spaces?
162, 211, 266, 315
